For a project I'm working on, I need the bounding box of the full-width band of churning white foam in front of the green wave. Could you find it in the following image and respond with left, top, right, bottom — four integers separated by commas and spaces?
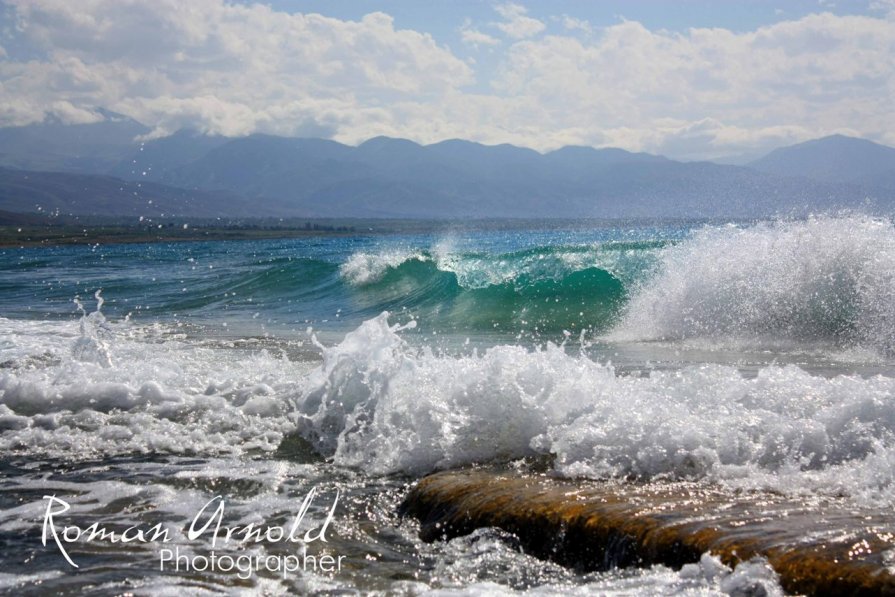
0, 302, 895, 505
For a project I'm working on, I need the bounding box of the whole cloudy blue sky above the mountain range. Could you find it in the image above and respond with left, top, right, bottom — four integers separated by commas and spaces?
0, 0, 895, 160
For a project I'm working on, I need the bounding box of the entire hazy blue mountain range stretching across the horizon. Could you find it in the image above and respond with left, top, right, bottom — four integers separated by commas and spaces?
0, 111, 895, 218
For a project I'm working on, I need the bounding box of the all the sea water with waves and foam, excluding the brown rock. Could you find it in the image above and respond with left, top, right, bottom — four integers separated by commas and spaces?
0, 215, 895, 594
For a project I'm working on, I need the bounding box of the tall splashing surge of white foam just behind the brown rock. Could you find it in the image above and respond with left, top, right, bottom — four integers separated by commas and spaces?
297, 314, 895, 504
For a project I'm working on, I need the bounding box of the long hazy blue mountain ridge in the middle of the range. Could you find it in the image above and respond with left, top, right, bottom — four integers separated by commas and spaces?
126, 135, 895, 218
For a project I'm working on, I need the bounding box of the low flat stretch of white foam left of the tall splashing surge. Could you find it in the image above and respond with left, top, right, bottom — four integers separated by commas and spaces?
0, 314, 312, 459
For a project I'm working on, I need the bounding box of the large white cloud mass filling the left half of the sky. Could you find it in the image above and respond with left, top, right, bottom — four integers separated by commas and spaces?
0, 0, 473, 134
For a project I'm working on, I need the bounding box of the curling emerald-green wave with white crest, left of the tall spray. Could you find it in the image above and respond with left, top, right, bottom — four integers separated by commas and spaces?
342, 246, 654, 334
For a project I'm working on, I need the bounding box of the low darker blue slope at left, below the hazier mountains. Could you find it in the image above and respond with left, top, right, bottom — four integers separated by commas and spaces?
0, 168, 302, 219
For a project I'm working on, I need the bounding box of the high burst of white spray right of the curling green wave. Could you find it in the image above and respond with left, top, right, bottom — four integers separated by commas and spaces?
610, 216, 895, 353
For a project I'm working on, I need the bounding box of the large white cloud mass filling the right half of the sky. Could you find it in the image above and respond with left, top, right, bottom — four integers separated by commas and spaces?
486, 14, 895, 158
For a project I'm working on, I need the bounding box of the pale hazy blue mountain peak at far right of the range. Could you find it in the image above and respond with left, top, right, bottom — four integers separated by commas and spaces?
749, 135, 895, 188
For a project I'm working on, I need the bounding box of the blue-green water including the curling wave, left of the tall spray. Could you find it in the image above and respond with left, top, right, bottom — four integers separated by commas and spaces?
0, 228, 686, 334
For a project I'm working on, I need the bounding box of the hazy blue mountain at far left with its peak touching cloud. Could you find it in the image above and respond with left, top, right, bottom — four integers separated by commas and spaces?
0, 109, 149, 174
